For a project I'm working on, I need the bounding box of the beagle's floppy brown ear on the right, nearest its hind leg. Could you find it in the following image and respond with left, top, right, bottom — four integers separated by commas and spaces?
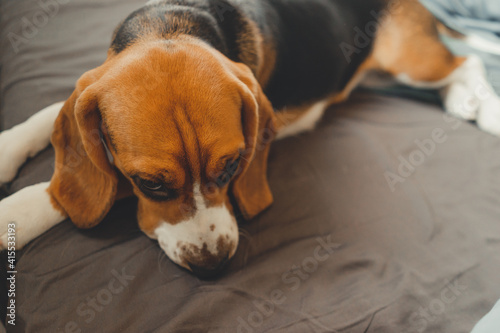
232, 65, 276, 219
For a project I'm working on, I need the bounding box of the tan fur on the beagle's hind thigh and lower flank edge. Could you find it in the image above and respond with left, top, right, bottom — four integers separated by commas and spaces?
278, 0, 465, 122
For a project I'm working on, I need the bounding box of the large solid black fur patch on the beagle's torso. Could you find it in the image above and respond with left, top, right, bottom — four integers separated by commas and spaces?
256, 0, 384, 109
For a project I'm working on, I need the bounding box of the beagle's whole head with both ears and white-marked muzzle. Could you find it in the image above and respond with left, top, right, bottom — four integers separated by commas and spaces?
50, 39, 274, 275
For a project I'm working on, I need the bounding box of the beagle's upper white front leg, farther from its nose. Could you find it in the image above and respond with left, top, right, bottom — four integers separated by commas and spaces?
0, 102, 64, 184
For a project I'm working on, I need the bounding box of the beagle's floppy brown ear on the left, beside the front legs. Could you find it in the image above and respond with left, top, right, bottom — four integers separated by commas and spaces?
49, 77, 118, 228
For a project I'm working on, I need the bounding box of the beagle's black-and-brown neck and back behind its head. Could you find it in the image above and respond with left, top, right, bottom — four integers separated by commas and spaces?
111, 0, 385, 109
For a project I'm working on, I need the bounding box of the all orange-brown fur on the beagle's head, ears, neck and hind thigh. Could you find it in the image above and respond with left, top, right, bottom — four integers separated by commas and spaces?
49, 0, 463, 235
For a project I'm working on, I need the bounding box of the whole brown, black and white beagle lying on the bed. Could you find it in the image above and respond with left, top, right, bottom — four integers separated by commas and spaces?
0, 0, 500, 276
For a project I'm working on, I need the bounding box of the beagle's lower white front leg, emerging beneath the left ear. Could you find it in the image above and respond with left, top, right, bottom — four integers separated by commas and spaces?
0, 182, 66, 250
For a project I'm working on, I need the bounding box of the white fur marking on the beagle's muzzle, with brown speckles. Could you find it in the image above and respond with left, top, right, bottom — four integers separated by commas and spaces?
154, 184, 239, 268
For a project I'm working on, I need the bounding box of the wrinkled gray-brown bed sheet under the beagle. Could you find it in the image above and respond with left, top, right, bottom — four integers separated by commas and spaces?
0, 0, 500, 333
